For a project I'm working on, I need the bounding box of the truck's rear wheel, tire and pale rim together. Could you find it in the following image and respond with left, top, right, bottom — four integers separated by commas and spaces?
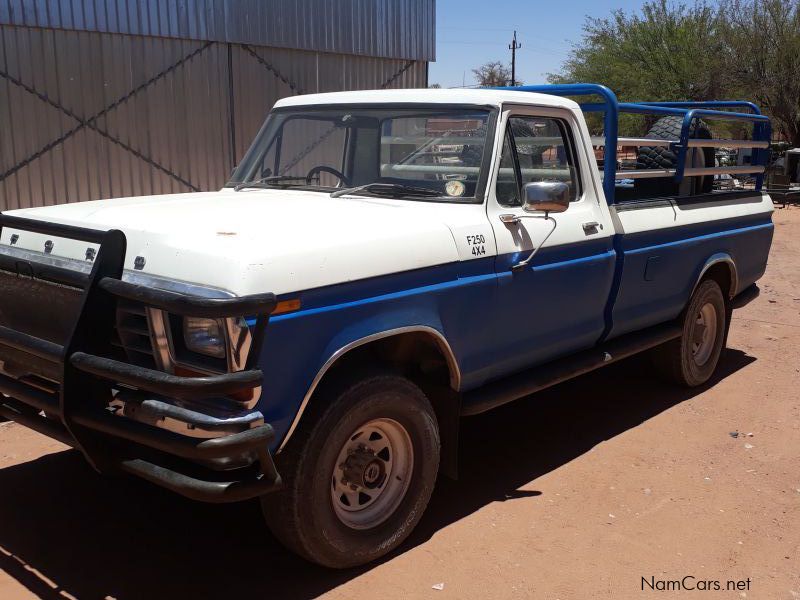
653, 279, 730, 387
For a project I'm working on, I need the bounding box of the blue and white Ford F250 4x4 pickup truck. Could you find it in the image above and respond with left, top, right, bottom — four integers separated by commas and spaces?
0, 84, 773, 567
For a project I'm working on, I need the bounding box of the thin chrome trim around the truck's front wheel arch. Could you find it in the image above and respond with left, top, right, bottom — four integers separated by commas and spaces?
277, 325, 461, 452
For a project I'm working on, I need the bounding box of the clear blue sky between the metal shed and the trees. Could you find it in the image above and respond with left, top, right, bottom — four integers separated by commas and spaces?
430, 0, 642, 87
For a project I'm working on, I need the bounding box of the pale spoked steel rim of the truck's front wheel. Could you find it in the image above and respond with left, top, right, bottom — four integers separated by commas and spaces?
331, 419, 414, 529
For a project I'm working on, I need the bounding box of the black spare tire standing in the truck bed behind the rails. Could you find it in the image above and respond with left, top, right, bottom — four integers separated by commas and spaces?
634, 116, 715, 198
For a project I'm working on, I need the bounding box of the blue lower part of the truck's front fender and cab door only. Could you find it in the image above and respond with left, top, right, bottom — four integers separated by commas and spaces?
259, 239, 614, 446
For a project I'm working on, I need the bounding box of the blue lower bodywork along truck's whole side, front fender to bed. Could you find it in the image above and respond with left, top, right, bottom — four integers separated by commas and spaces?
259, 214, 772, 447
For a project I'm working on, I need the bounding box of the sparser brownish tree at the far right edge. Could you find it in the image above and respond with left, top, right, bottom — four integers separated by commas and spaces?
721, 0, 800, 147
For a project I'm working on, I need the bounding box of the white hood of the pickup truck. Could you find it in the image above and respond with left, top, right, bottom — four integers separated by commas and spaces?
0, 190, 458, 295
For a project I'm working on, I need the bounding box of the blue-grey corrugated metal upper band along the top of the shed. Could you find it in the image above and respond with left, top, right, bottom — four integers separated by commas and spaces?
0, 0, 436, 61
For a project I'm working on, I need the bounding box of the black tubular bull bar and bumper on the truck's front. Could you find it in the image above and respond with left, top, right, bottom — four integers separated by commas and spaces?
0, 215, 281, 502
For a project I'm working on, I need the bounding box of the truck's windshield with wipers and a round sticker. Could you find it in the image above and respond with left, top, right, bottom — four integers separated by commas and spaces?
227, 105, 492, 202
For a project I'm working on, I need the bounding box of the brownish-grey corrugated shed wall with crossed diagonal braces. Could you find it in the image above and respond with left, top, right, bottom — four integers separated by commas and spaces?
0, 0, 432, 210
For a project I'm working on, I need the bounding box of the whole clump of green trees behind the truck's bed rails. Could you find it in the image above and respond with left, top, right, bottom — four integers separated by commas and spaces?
548, 0, 800, 138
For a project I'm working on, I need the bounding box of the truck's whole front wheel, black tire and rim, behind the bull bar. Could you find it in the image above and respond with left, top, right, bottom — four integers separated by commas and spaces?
262, 374, 440, 568
